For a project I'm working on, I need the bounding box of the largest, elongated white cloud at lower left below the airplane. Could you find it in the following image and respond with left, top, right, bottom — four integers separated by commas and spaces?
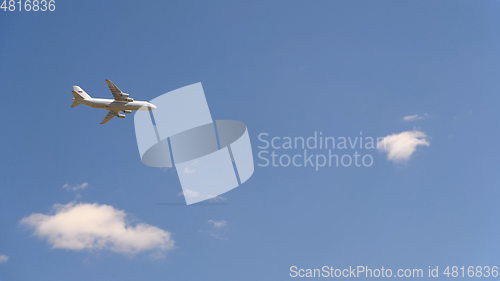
21, 203, 174, 254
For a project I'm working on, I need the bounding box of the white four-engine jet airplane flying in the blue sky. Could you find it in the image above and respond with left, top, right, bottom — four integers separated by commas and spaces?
71, 80, 156, 124
